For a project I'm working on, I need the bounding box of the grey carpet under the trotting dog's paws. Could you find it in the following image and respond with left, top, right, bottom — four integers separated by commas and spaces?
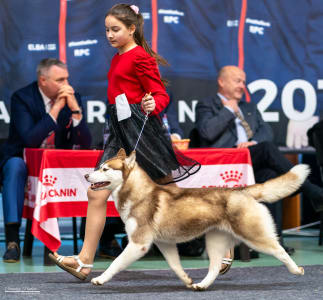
0, 265, 323, 300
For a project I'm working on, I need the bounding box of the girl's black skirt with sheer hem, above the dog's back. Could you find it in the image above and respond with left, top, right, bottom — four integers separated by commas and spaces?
97, 104, 201, 184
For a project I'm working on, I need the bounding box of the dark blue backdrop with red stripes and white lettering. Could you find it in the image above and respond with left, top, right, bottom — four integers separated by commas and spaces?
0, 0, 323, 146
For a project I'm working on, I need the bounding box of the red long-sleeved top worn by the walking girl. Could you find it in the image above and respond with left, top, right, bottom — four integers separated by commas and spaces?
108, 46, 169, 115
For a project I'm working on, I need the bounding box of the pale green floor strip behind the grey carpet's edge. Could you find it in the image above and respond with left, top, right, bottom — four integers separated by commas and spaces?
0, 235, 323, 274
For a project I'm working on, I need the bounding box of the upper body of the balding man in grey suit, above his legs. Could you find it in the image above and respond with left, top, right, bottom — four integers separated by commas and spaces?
196, 66, 273, 148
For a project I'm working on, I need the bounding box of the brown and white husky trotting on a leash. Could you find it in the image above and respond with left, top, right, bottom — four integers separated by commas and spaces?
85, 149, 309, 290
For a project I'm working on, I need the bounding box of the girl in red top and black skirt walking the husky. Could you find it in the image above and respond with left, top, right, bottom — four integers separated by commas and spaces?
50, 4, 199, 280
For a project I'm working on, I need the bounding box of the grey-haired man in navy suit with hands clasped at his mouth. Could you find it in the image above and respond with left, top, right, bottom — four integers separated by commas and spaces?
0, 58, 91, 262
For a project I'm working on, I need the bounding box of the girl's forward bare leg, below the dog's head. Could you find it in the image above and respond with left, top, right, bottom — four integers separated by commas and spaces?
54, 188, 111, 274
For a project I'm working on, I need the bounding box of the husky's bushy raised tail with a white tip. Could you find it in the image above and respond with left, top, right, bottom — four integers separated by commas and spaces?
245, 164, 310, 203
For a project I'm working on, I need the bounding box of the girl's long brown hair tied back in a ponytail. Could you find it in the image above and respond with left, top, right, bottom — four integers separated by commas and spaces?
105, 3, 169, 66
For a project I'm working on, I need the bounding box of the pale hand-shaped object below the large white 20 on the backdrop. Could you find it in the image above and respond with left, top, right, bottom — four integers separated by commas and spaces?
286, 116, 319, 149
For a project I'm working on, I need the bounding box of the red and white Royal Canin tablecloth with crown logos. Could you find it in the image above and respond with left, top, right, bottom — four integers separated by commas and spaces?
23, 148, 254, 251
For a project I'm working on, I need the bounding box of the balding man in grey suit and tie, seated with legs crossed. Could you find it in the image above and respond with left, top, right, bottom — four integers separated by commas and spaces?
196, 66, 323, 239
